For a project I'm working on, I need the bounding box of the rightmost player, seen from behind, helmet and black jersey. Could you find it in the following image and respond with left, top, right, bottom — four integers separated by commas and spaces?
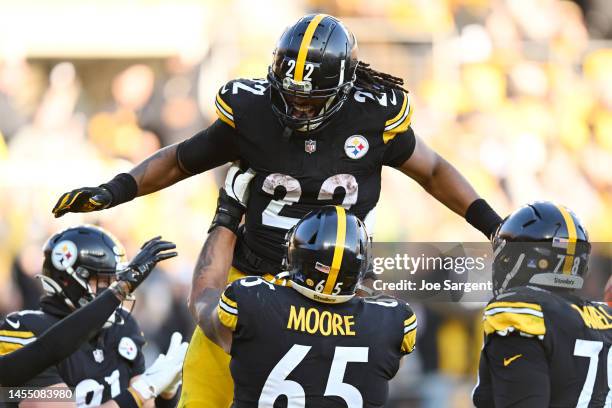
473, 202, 612, 408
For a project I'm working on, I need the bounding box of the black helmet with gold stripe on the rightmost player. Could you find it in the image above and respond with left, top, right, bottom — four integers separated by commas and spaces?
493, 201, 591, 295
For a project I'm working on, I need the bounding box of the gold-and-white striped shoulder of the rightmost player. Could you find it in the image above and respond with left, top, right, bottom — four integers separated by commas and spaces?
483, 287, 550, 340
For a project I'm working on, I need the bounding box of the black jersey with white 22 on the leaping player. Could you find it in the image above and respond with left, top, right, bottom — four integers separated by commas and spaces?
215, 79, 415, 274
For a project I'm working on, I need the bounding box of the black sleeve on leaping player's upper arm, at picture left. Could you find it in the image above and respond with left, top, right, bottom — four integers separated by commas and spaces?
176, 119, 238, 175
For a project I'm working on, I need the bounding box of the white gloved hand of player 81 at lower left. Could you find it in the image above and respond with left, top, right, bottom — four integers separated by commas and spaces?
131, 332, 188, 400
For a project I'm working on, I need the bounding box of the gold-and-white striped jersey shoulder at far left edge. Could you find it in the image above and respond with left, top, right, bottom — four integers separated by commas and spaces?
0, 310, 44, 356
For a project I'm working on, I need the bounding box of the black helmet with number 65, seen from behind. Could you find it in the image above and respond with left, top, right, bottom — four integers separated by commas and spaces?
285, 205, 370, 303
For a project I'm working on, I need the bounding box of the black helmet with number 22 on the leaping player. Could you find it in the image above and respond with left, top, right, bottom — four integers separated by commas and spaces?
268, 14, 357, 131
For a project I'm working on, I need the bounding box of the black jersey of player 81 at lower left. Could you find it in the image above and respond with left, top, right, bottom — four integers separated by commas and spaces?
0, 309, 145, 408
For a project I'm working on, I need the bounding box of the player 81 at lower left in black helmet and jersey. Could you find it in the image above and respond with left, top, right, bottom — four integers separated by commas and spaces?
0, 225, 187, 407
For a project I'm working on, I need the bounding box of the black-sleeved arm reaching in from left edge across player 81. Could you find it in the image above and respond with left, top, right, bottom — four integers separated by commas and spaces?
0, 234, 161, 386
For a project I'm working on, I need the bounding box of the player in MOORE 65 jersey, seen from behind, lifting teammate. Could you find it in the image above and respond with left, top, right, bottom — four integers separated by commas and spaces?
196, 206, 417, 408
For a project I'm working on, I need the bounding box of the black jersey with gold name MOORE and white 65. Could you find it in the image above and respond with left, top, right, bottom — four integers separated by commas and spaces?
217, 277, 417, 408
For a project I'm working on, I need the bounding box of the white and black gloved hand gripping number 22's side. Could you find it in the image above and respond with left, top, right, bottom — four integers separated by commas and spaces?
208, 162, 255, 233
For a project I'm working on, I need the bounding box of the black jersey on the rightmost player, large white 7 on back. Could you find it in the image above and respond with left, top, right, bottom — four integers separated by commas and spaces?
474, 286, 612, 408
